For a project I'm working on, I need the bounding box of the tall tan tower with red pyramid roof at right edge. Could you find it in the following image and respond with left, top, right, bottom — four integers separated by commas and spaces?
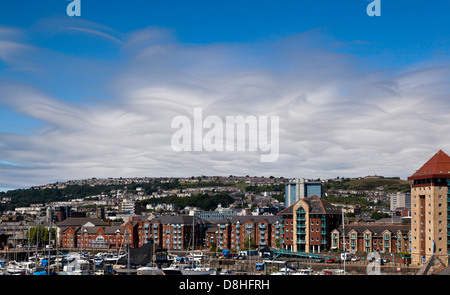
408, 150, 450, 265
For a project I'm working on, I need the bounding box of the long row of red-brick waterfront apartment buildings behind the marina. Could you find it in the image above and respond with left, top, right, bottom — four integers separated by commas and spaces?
58, 196, 411, 260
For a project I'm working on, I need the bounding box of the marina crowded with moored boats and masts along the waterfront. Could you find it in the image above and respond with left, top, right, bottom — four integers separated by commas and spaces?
0, 247, 419, 276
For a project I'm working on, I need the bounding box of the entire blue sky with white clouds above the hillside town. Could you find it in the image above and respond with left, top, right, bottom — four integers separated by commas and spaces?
0, 0, 450, 189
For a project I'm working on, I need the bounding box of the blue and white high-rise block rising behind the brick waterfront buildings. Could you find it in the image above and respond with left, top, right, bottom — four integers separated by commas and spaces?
285, 178, 324, 207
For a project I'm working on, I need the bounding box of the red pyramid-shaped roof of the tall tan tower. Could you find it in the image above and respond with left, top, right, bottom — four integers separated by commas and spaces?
408, 150, 450, 180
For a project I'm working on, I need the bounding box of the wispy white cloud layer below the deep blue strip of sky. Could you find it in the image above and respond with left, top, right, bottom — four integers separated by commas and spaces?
0, 22, 450, 188
